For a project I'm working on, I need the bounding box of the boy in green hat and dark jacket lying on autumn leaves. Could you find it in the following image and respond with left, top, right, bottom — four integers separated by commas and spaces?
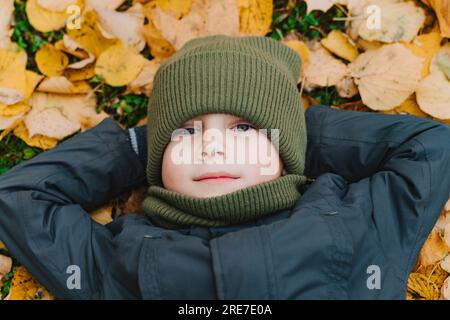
0, 36, 450, 299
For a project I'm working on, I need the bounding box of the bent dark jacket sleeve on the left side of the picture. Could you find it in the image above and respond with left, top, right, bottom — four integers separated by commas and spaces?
0, 118, 145, 299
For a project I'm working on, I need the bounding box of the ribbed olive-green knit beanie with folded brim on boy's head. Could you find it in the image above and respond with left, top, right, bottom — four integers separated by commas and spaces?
147, 35, 307, 186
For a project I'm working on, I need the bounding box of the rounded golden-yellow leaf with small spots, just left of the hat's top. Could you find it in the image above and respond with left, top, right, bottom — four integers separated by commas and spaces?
95, 43, 145, 86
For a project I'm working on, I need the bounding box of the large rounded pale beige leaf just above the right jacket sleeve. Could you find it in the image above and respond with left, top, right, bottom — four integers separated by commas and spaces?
348, 44, 423, 110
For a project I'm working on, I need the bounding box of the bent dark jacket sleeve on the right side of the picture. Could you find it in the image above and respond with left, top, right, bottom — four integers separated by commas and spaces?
305, 105, 450, 274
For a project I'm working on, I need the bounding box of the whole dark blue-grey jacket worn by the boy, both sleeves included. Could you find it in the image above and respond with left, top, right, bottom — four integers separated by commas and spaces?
0, 105, 450, 299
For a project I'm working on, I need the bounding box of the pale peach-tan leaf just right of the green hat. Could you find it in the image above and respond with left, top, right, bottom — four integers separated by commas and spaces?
304, 44, 347, 90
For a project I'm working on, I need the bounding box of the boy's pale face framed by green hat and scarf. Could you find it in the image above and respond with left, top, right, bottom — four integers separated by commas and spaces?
162, 113, 285, 198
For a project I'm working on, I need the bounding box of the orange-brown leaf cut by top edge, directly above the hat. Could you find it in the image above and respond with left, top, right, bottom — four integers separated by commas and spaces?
237, 0, 273, 36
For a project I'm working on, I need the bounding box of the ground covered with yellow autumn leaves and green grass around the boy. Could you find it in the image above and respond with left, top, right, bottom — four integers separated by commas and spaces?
0, 0, 450, 299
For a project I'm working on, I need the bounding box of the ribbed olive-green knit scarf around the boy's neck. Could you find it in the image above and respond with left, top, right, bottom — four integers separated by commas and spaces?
144, 174, 306, 229
